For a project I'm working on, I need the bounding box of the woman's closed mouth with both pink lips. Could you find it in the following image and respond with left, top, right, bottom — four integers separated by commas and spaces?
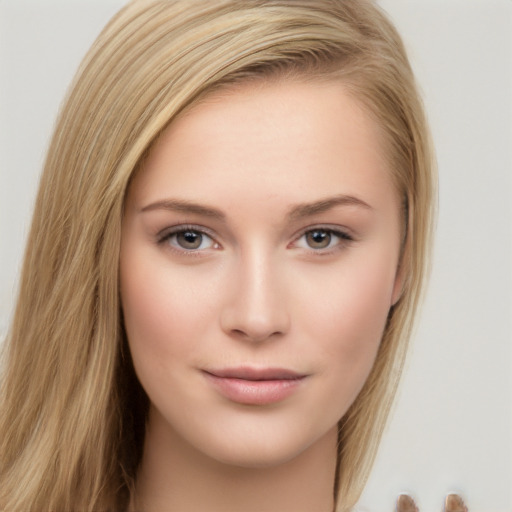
203, 367, 308, 405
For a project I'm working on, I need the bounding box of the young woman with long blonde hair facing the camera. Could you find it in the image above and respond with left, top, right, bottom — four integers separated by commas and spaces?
0, 0, 433, 511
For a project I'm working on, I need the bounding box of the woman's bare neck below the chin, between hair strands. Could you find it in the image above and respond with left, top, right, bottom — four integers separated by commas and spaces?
130, 408, 337, 512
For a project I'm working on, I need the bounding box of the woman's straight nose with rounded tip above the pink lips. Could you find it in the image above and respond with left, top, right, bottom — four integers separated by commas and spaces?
220, 250, 290, 343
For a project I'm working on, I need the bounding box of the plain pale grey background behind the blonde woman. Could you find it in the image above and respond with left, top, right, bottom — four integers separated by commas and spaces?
0, 0, 512, 512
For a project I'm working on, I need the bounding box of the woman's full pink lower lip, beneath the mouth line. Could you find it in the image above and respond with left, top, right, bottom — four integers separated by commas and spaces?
204, 372, 305, 405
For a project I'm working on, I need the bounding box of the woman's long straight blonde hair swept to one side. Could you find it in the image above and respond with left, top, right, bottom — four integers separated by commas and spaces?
0, 0, 434, 512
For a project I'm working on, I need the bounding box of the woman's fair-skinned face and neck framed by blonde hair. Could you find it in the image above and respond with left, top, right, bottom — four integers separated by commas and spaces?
121, 80, 401, 512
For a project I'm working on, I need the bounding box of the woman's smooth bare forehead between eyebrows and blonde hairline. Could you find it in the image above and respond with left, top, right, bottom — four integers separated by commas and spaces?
127, 80, 391, 214
